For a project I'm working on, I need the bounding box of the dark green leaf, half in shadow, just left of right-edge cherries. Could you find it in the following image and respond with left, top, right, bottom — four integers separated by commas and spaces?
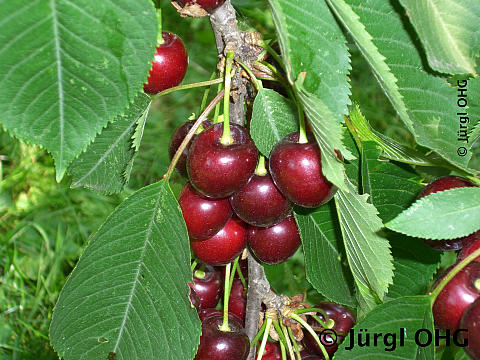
387, 233, 442, 298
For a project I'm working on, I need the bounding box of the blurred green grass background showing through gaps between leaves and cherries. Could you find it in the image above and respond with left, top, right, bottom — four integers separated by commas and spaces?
0, 0, 412, 360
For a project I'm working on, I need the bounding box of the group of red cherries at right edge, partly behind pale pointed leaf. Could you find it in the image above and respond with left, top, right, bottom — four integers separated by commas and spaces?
418, 176, 480, 359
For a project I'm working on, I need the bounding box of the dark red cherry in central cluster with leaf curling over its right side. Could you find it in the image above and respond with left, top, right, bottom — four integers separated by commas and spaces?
270, 133, 336, 207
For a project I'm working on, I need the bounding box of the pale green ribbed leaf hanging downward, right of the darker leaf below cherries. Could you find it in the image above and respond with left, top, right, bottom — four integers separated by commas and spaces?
335, 180, 393, 300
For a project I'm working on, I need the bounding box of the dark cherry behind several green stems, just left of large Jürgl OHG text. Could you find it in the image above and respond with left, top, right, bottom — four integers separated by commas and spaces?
303, 302, 355, 356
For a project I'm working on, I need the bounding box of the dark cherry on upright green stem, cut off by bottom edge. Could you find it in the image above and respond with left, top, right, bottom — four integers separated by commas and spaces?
194, 316, 250, 360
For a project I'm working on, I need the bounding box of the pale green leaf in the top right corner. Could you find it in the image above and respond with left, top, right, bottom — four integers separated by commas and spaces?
400, 0, 480, 74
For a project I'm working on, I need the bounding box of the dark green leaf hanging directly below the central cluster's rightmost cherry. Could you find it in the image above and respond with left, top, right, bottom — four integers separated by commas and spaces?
295, 202, 354, 306
